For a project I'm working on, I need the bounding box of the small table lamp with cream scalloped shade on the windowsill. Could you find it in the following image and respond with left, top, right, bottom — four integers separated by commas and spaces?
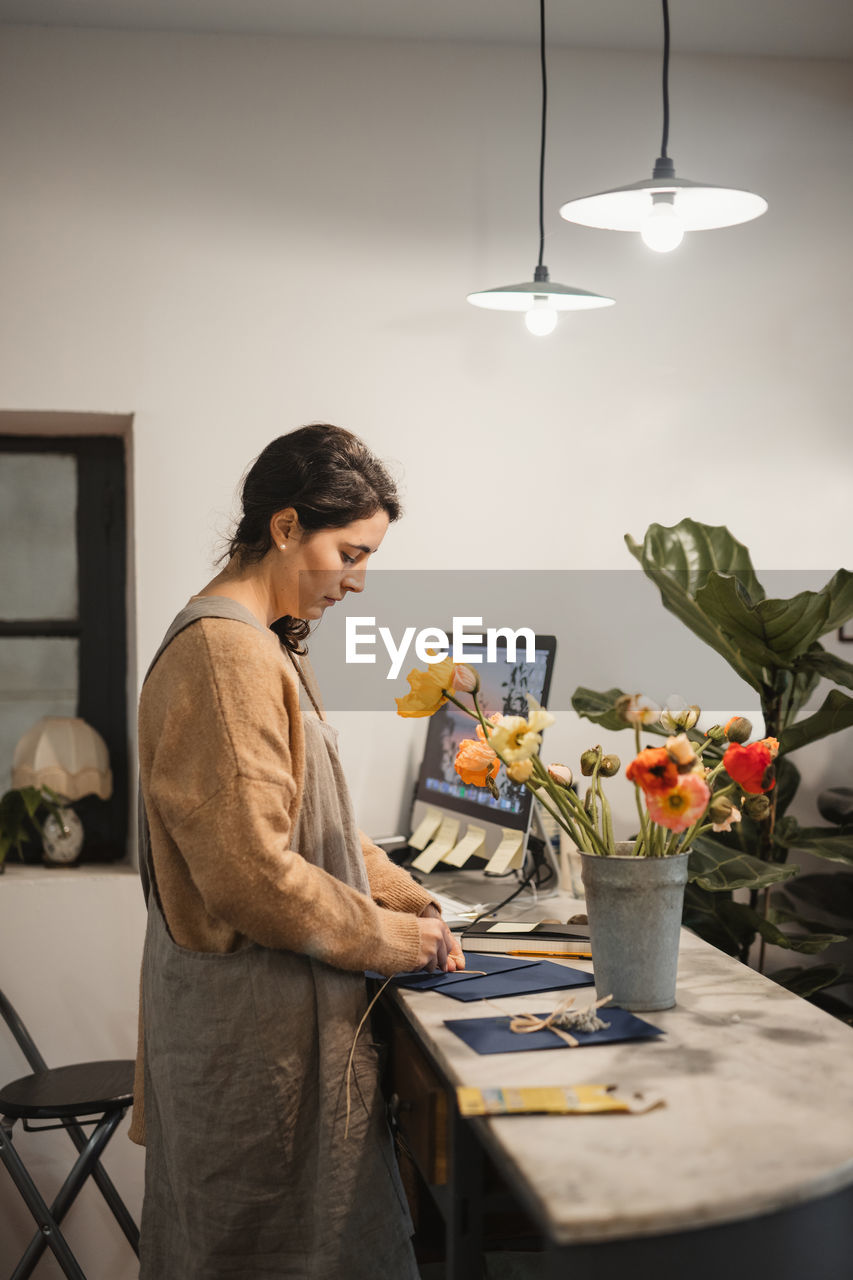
12, 716, 113, 867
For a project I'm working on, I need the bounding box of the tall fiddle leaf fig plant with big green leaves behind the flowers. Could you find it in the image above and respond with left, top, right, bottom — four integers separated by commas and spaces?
573, 520, 853, 1011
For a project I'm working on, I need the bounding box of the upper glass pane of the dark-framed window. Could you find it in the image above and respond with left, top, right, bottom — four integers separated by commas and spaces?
0, 453, 77, 622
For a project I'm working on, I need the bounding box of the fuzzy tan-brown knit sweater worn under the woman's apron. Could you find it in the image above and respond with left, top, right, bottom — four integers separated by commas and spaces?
131, 618, 432, 1142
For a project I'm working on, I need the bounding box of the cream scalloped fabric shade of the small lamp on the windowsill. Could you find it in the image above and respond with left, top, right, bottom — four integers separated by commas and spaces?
12, 716, 113, 800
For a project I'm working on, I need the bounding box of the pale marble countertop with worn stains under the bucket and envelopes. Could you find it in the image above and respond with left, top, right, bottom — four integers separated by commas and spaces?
396, 904, 853, 1244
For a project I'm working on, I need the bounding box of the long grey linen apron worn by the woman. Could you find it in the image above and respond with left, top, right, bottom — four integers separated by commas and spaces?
140, 596, 419, 1280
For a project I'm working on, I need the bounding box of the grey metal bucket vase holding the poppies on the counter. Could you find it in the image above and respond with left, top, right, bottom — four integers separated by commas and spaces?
581, 844, 690, 1011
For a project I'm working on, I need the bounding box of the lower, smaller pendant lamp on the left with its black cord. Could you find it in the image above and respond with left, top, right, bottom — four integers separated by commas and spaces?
467, 0, 613, 337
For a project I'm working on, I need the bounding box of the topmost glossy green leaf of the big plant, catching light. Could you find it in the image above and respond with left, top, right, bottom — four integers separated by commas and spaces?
625, 520, 765, 692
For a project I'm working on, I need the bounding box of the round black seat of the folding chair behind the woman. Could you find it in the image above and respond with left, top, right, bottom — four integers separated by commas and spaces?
0, 1059, 134, 1120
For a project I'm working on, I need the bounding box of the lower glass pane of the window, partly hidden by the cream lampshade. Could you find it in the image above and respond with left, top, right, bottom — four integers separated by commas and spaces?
0, 636, 78, 792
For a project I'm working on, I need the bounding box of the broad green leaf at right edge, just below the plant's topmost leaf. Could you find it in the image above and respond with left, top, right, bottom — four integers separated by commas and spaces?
695, 570, 853, 667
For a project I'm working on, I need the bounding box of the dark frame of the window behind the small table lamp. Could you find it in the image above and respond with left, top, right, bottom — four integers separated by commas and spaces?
0, 434, 129, 863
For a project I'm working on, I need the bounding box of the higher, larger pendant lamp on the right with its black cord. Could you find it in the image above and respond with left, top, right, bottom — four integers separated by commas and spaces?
560, 0, 767, 253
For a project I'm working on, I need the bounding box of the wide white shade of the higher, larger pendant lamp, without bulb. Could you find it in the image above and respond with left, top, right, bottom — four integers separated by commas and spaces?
560, 178, 767, 232
